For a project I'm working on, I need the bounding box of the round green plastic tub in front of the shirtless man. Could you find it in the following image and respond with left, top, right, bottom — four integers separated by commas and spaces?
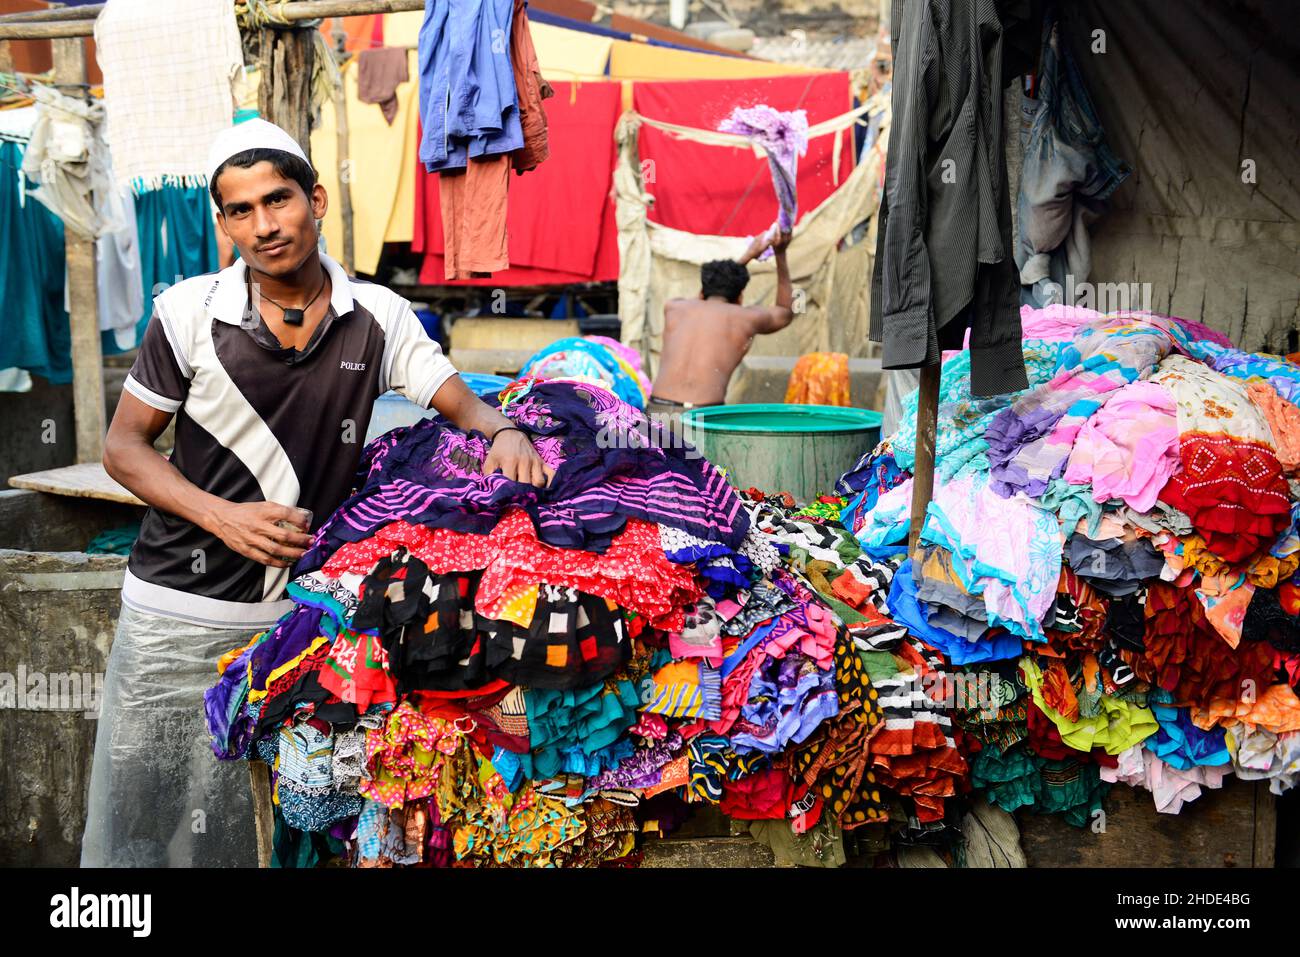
681, 403, 880, 502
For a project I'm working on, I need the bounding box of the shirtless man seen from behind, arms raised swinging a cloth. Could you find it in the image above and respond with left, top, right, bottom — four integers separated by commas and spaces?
646, 233, 794, 416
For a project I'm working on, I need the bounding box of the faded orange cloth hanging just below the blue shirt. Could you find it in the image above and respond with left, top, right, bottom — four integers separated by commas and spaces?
438, 153, 510, 280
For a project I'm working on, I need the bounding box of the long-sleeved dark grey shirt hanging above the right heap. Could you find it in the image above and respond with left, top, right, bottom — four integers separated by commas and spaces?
871, 0, 1037, 395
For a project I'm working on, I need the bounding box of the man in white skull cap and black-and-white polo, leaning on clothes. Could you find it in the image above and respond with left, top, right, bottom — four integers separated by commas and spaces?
82, 120, 551, 867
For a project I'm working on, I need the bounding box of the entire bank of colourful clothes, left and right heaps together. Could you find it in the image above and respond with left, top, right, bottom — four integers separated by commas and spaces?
207, 307, 1300, 867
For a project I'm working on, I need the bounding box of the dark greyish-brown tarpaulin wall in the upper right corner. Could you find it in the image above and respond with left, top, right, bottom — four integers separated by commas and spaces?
1061, 0, 1300, 352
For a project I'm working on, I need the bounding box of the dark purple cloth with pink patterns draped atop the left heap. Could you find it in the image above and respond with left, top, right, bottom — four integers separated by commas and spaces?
294, 382, 749, 577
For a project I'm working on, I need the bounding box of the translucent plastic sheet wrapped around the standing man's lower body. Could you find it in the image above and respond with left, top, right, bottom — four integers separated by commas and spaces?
81, 606, 257, 867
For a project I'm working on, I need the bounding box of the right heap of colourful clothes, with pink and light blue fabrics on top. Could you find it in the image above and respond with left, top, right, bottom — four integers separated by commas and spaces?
837, 307, 1300, 824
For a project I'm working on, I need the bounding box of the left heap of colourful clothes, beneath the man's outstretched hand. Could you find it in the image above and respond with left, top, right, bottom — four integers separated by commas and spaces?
207, 380, 894, 866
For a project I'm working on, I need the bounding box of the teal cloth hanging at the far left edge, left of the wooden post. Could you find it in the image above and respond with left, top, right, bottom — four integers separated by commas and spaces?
0, 140, 73, 385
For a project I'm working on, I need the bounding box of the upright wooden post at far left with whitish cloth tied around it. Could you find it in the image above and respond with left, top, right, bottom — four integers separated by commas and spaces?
51, 39, 105, 463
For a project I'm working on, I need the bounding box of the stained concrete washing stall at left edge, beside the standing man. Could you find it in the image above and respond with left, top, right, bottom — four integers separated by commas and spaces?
0, 490, 144, 867
